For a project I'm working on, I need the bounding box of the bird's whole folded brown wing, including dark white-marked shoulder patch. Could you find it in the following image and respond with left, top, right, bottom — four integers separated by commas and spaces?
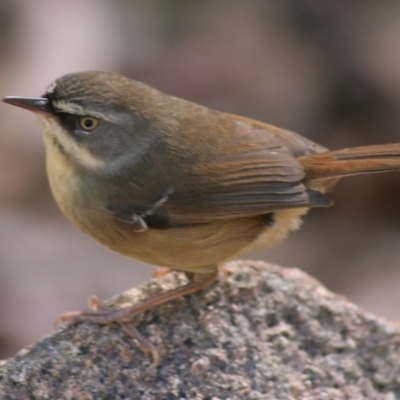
108, 120, 331, 230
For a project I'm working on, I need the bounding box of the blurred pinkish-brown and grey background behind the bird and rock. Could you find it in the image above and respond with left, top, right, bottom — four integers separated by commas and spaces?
0, 0, 400, 357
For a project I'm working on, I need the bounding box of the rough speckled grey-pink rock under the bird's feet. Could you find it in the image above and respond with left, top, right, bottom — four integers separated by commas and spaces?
0, 261, 400, 400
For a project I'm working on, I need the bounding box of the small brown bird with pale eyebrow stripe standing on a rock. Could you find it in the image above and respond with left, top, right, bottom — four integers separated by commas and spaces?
4, 71, 400, 364
